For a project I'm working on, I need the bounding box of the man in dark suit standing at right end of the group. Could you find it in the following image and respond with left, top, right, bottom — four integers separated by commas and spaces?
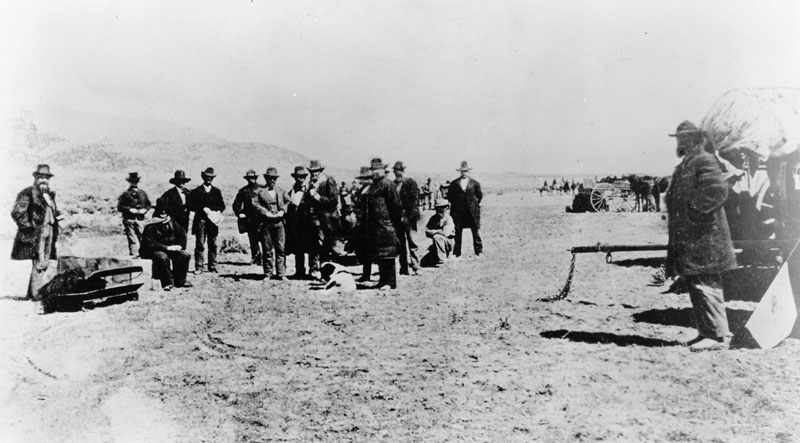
447, 161, 483, 258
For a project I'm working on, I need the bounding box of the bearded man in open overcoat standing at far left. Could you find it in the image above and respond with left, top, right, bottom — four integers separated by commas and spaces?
11, 164, 62, 300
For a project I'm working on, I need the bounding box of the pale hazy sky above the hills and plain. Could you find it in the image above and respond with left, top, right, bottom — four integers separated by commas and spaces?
0, 0, 800, 174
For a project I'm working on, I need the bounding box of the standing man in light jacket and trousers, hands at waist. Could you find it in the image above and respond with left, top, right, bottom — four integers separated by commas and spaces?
252, 167, 286, 280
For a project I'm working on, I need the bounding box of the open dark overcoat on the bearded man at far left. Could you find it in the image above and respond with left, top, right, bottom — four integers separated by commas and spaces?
11, 186, 58, 260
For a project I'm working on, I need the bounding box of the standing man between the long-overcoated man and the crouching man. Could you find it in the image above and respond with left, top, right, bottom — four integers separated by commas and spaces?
392, 161, 419, 275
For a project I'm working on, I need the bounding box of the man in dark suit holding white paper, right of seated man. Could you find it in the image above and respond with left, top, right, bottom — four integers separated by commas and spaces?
189, 167, 225, 273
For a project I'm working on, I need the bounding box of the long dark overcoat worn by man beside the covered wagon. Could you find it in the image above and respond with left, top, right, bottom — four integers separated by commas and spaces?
665, 151, 736, 277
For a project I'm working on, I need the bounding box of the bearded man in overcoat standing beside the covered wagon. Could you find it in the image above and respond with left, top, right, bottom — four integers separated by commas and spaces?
666, 121, 736, 351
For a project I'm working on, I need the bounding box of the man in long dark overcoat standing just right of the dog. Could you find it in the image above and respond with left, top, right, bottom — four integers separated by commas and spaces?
359, 158, 402, 289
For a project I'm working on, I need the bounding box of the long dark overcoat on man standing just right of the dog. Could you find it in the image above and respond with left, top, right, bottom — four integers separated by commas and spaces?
359, 178, 401, 261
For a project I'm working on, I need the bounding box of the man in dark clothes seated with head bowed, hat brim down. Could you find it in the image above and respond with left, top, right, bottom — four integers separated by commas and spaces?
139, 199, 192, 291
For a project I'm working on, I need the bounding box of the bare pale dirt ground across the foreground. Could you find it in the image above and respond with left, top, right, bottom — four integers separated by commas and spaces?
0, 193, 800, 442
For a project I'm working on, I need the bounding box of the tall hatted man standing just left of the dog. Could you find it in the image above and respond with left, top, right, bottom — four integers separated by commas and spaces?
306, 160, 339, 279
